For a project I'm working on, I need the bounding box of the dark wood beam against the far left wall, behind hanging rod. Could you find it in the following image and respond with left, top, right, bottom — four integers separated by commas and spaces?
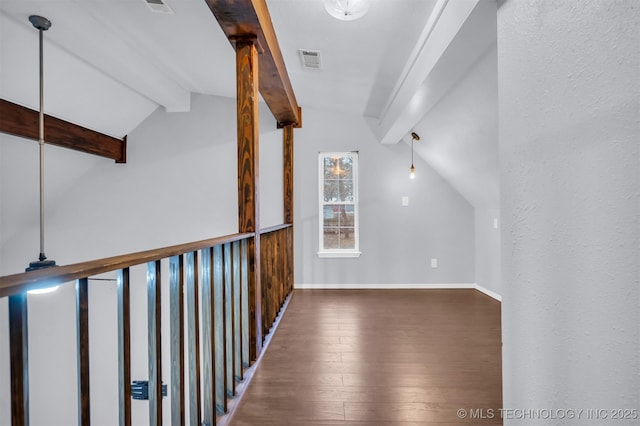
0, 99, 127, 163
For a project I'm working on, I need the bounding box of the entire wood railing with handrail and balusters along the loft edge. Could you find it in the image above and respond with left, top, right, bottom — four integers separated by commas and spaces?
0, 225, 293, 426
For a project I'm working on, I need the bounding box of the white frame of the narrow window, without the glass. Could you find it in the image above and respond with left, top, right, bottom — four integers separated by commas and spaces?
318, 151, 362, 257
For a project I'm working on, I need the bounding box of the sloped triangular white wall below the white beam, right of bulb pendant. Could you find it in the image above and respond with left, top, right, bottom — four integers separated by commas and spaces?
406, 44, 500, 210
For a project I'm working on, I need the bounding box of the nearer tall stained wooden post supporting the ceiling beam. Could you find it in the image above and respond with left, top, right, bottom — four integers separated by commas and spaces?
236, 38, 262, 360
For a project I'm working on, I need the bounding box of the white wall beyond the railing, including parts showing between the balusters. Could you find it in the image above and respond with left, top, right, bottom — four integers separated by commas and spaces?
0, 95, 282, 426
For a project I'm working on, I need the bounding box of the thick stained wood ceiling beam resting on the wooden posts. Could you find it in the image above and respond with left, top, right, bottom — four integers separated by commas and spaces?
205, 0, 301, 125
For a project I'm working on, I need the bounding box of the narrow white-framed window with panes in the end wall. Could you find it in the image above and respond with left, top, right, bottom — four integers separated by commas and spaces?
318, 152, 360, 257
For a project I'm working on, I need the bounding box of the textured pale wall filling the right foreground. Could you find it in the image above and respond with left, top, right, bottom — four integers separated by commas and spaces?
498, 0, 640, 426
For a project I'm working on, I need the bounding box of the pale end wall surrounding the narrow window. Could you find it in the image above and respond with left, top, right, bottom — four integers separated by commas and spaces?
294, 108, 474, 285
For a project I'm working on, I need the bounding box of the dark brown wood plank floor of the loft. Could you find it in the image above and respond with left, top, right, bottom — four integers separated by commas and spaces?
230, 290, 502, 426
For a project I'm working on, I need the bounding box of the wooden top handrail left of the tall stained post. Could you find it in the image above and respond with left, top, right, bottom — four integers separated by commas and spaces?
0, 232, 255, 297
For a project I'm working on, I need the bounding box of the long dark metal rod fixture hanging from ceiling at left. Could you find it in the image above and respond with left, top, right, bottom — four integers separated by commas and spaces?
26, 15, 56, 271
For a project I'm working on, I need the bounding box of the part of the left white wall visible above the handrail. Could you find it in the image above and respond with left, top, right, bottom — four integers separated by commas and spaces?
0, 95, 282, 275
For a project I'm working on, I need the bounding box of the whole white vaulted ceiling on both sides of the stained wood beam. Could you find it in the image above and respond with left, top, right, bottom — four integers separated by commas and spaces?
0, 0, 497, 209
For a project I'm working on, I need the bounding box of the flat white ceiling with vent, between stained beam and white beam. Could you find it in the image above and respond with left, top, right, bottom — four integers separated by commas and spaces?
267, 0, 435, 117
